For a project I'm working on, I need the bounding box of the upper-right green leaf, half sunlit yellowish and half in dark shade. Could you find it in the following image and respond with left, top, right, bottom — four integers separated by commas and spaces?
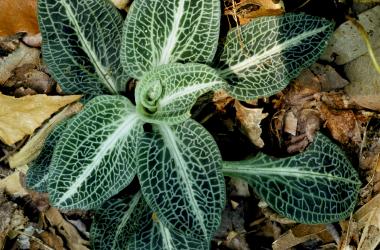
220, 14, 334, 100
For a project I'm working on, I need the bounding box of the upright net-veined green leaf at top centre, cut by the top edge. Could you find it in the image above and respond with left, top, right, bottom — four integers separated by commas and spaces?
121, 0, 220, 79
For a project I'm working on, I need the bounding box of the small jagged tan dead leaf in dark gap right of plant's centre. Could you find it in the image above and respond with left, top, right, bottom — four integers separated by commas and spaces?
235, 100, 268, 148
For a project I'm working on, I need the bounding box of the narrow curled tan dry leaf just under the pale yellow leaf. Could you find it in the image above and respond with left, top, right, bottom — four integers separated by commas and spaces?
9, 103, 83, 168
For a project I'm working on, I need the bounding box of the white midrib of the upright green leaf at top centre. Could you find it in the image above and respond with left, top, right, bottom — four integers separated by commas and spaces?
159, 0, 185, 65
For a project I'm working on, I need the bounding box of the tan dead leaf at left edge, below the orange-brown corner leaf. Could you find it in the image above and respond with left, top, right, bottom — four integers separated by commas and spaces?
0, 43, 40, 85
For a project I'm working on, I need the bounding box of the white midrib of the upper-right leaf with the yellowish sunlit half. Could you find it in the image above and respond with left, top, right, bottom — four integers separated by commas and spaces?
220, 26, 328, 77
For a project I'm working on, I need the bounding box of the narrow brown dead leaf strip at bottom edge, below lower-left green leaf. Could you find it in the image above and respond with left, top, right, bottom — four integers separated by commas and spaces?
44, 207, 89, 250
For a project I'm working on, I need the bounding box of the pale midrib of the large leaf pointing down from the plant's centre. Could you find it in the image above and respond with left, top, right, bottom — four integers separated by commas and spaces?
159, 125, 208, 236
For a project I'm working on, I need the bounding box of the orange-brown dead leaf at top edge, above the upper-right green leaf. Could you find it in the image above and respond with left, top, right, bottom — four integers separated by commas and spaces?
224, 0, 285, 25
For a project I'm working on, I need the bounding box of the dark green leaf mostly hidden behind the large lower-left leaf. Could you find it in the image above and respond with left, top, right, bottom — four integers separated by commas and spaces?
26, 120, 68, 193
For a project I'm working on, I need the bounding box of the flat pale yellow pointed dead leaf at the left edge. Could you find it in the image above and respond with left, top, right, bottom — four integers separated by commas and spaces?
0, 93, 81, 145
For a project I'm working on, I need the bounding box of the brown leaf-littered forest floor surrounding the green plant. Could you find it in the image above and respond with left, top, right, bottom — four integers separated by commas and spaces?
0, 0, 380, 250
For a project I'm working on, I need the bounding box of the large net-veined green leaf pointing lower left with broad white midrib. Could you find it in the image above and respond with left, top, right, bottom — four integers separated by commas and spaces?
48, 96, 143, 209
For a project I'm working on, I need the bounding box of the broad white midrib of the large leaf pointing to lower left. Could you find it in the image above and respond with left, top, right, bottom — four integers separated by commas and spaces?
56, 114, 138, 206
